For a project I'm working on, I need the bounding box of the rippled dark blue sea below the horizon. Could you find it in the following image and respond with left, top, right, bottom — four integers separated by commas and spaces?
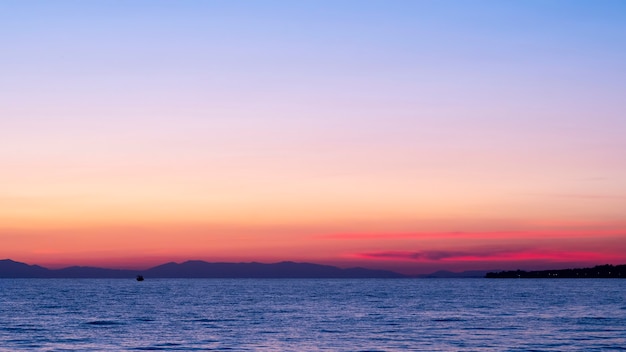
0, 278, 626, 351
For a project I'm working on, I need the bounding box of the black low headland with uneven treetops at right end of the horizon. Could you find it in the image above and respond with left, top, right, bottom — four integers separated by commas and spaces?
485, 264, 626, 279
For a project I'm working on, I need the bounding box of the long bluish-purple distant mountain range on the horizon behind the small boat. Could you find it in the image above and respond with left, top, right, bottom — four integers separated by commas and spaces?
0, 259, 407, 279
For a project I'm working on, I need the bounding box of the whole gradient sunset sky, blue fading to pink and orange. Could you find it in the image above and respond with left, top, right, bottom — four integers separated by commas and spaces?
0, 0, 626, 274
